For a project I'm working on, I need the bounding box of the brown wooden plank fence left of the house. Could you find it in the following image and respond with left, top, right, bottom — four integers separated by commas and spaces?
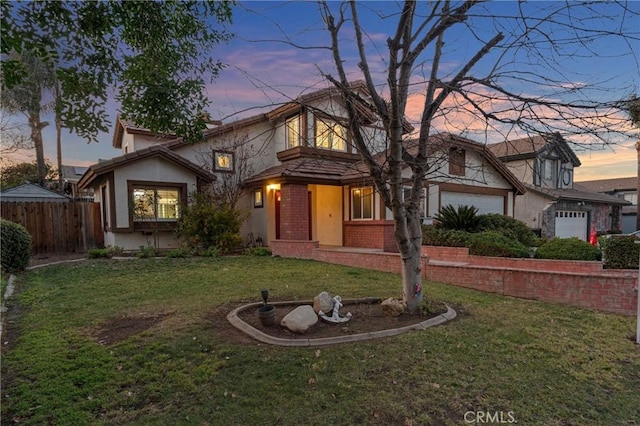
0, 202, 104, 254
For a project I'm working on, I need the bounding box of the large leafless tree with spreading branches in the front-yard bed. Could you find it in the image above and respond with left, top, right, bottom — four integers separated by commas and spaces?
308, 1, 639, 312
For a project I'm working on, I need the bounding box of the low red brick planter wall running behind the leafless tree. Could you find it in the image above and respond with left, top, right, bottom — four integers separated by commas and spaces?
271, 240, 638, 315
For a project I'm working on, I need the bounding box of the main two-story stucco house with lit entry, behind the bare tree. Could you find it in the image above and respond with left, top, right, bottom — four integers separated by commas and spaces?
80, 86, 525, 251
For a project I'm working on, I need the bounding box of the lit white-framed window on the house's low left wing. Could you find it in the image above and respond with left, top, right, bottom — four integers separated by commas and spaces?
132, 185, 180, 222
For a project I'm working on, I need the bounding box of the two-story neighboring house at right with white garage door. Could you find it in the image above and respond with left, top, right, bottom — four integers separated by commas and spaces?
488, 134, 629, 241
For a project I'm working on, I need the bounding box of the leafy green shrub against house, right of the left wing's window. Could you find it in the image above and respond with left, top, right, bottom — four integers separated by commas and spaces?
178, 194, 244, 253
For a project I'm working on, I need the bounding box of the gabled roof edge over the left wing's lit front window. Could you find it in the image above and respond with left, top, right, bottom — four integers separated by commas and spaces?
78, 145, 216, 189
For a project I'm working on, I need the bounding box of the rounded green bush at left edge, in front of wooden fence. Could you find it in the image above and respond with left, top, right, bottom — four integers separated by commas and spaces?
0, 219, 32, 272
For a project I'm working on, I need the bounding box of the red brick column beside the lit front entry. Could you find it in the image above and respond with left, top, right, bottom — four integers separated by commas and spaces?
280, 184, 309, 241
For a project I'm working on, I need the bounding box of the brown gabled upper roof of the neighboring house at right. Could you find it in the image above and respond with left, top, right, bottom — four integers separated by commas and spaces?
487, 133, 581, 167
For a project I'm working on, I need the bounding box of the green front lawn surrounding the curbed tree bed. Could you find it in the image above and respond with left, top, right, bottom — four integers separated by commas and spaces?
2, 257, 640, 425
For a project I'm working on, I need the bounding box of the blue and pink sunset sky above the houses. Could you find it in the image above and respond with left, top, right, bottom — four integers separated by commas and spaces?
6, 1, 640, 181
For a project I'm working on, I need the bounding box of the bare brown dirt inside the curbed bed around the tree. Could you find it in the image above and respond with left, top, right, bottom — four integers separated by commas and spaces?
216, 303, 446, 339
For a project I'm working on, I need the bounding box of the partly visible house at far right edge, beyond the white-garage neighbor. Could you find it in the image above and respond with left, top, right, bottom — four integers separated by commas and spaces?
576, 176, 638, 234
